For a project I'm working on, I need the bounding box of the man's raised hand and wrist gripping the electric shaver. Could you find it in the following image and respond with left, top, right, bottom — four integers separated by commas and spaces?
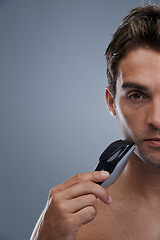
30, 171, 111, 240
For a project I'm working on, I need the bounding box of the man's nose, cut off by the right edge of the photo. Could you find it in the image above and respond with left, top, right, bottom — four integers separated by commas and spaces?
147, 97, 160, 130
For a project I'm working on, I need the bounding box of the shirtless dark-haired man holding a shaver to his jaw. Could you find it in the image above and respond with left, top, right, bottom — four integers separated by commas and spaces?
31, 5, 160, 240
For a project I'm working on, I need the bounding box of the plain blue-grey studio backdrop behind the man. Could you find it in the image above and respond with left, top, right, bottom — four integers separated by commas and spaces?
0, 0, 159, 240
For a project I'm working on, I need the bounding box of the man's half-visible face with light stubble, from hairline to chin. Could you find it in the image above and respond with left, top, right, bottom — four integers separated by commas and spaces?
107, 48, 160, 166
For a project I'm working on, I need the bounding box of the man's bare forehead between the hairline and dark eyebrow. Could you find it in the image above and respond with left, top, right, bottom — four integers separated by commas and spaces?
117, 48, 160, 87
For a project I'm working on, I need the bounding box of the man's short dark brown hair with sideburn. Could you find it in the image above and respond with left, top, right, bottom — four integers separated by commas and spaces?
105, 5, 160, 97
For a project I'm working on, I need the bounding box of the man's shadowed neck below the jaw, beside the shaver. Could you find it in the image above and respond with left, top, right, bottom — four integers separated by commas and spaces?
122, 154, 160, 199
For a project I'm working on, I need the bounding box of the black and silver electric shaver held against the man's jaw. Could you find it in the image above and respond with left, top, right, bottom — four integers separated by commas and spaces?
95, 140, 135, 188
